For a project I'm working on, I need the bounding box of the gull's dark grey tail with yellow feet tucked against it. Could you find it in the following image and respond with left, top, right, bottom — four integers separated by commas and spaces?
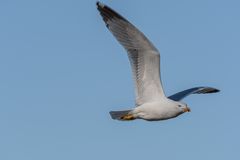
109, 110, 136, 121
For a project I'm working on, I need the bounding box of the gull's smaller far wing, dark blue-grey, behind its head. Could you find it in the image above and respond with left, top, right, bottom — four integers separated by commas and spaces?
168, 87, 220, 101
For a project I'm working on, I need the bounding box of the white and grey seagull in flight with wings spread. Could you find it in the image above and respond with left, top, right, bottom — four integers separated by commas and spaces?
96, 1, 219, 121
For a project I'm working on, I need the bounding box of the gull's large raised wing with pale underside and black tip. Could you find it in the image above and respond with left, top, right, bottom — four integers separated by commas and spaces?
97, 2, 164, 106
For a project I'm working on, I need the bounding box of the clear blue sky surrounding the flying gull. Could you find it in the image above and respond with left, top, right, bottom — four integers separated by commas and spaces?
0, 0, 240, 160
